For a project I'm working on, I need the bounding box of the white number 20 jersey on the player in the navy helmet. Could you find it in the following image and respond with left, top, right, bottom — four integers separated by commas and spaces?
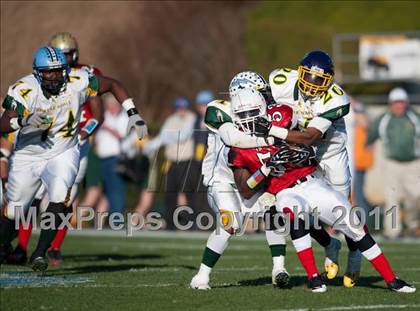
269, 68, 350, 160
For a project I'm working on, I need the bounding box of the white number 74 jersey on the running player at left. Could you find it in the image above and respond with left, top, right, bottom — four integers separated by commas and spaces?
3, 69, 99, 161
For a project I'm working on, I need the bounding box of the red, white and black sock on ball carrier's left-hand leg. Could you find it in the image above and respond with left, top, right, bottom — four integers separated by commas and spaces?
290, 219, 319, 279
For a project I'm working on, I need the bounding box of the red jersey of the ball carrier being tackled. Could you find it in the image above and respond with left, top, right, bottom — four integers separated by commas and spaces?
229, 104, 316, 194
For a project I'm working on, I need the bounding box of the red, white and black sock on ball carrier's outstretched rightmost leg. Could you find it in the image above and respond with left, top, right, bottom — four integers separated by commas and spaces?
358, 233, 395, 283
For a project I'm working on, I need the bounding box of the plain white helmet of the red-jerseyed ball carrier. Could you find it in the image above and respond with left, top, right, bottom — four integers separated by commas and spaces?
231, 89, 267, 135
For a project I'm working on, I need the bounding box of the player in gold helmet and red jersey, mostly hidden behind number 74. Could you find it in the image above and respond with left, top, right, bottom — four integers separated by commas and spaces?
7, 32, 104, 266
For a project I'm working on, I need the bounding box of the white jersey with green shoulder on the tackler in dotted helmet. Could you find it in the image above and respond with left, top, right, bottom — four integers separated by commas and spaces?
201, 100, 235, 186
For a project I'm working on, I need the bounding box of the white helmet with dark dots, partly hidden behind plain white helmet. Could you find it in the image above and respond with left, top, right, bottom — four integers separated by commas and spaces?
229, 71, 270, 97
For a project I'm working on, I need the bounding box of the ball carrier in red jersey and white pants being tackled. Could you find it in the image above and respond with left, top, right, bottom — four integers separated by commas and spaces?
229, 89, 416, 293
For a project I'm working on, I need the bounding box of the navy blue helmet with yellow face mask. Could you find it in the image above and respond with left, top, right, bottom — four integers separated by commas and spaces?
298, 51, 334, 98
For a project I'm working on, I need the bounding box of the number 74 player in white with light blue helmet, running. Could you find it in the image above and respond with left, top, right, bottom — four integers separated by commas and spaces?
0, 46, 147, 271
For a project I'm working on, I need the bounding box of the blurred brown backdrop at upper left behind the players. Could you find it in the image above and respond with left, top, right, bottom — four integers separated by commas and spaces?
1, 1, 249, 125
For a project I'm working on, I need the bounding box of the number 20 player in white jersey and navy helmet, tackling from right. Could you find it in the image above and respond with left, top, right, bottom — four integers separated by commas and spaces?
269, 51, 361, 287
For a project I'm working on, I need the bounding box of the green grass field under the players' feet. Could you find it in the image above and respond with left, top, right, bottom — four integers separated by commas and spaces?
0, 232, 420, 311
